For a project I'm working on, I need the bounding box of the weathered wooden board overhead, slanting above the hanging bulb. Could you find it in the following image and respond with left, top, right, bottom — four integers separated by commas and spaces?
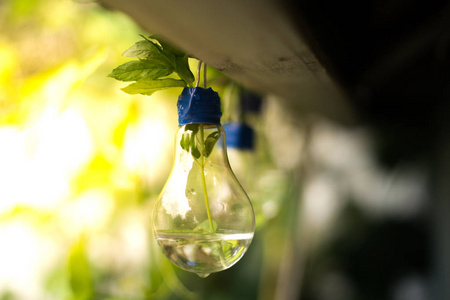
100, 0, 354, 122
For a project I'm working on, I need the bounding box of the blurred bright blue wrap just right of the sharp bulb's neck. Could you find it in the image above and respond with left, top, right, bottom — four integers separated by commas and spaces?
223, 122, 255, 150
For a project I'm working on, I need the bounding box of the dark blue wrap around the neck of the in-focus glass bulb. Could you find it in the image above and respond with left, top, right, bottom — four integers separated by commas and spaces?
177, 87, 222, 126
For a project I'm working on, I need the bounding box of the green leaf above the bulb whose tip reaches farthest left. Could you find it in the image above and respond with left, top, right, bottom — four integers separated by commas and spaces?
108, 59, 174, 81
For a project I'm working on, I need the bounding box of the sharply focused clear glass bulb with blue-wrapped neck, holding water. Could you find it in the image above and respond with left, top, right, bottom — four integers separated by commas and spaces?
153, 87, 255, 278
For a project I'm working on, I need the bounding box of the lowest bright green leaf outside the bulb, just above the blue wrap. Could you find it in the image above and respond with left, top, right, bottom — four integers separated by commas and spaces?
122, 78, 186, 96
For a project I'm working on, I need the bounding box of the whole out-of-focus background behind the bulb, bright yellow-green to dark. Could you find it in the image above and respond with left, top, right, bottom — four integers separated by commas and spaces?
0, 0, 430, 300
